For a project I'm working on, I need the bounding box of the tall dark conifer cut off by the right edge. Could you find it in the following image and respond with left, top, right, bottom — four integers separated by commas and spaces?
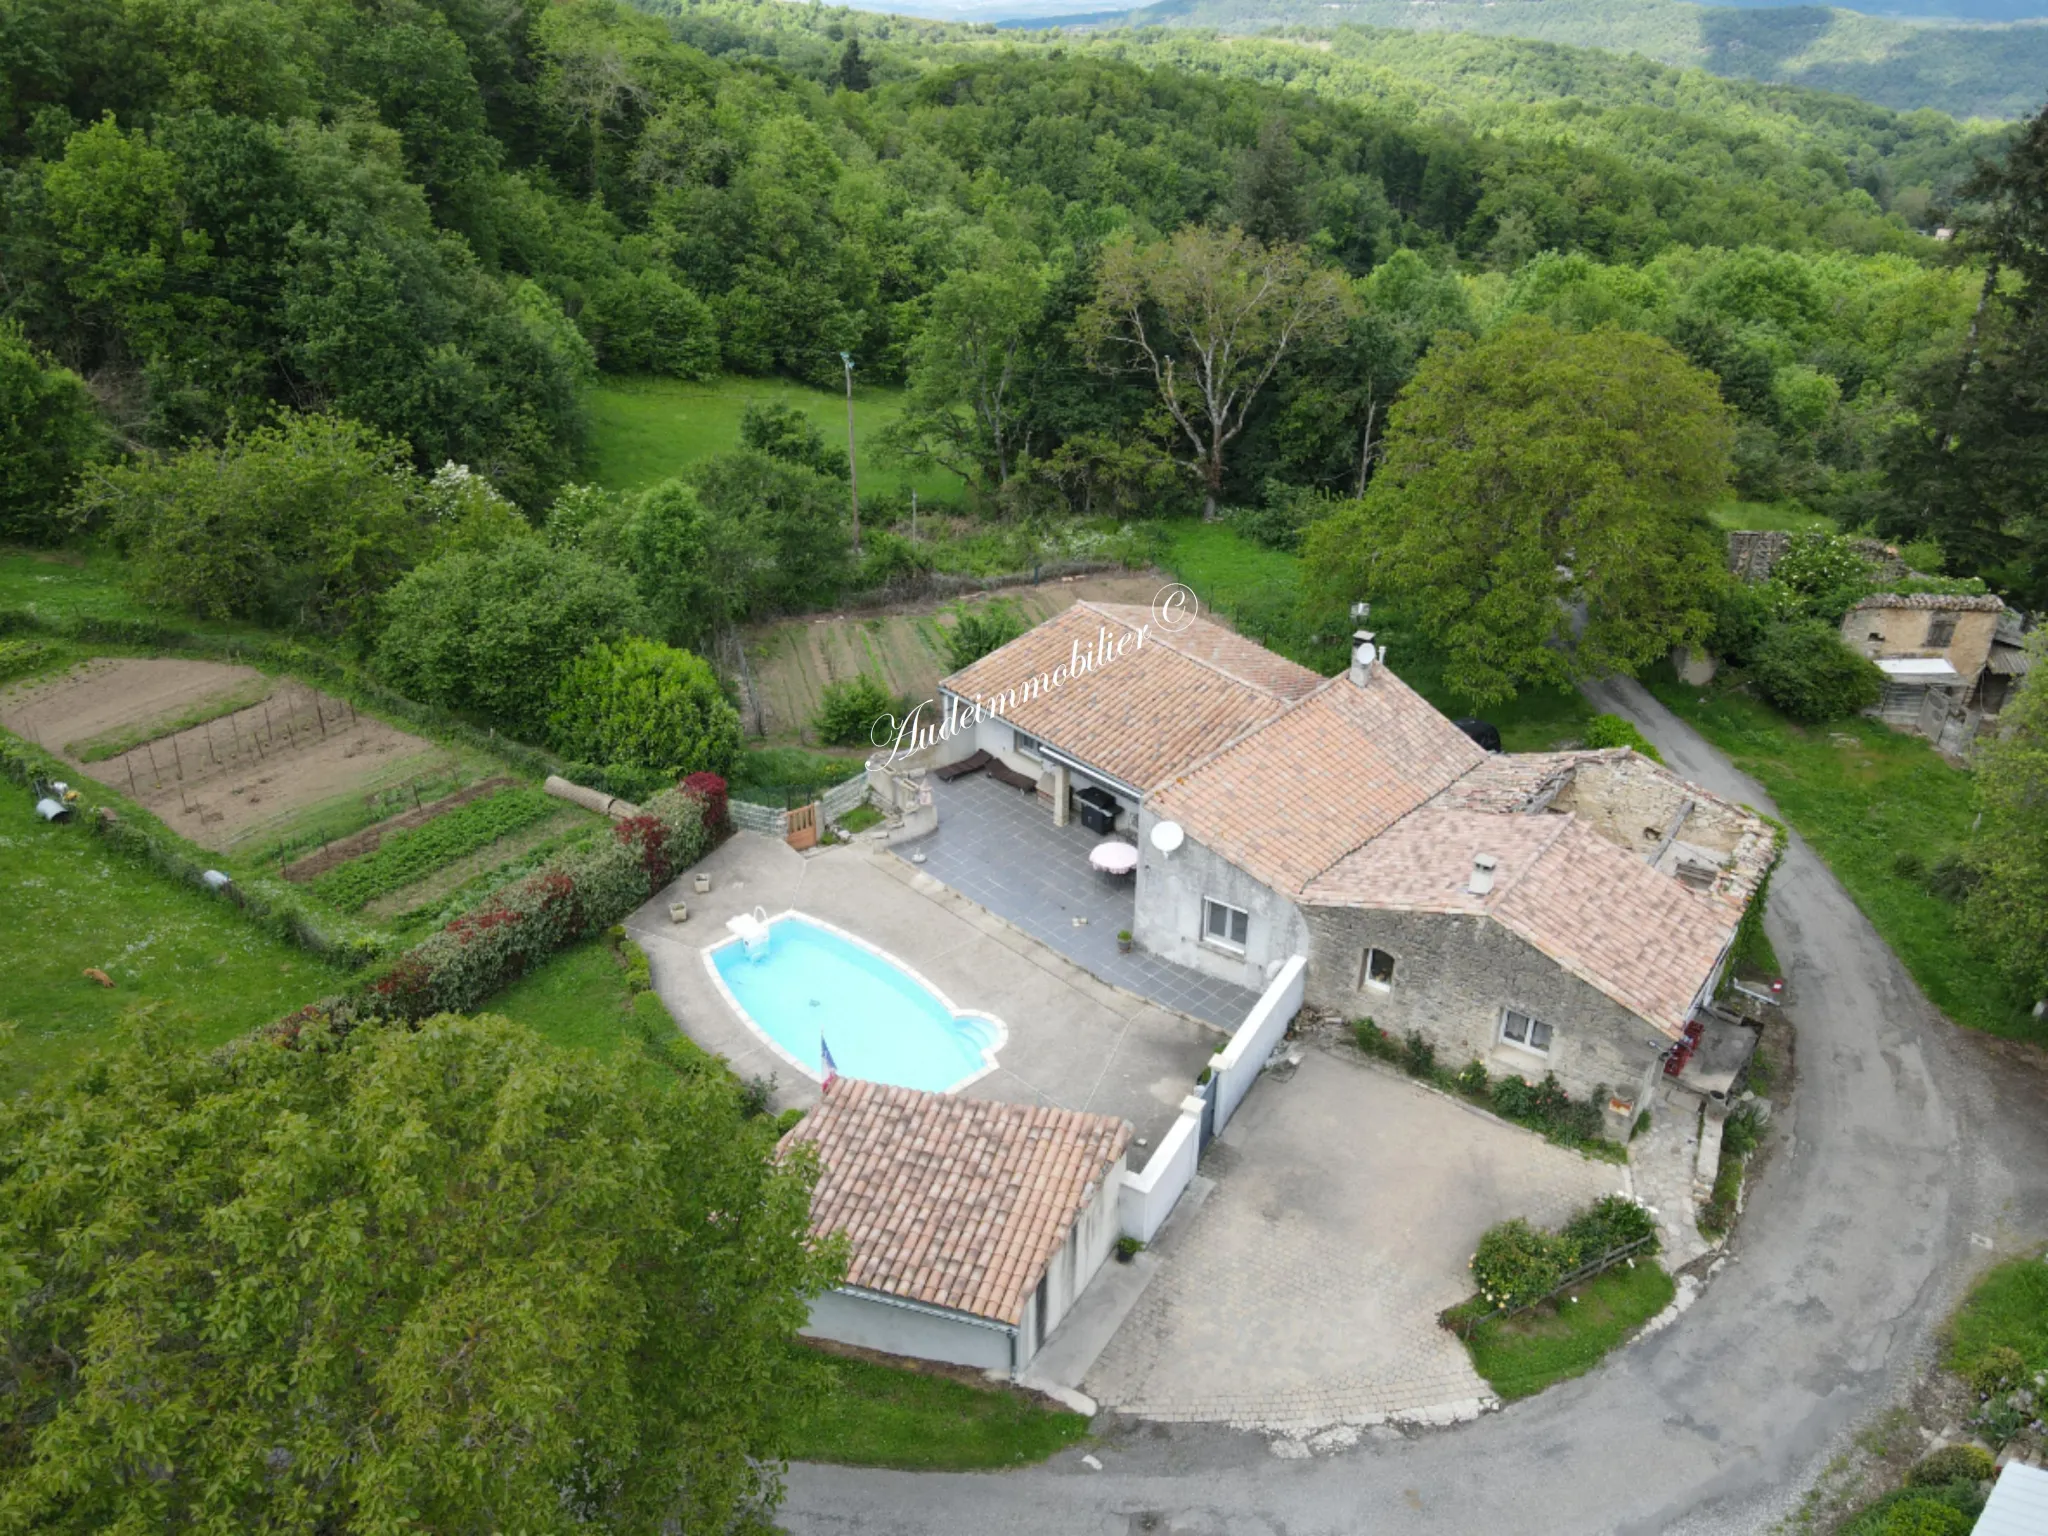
1880, 100, 2048, 608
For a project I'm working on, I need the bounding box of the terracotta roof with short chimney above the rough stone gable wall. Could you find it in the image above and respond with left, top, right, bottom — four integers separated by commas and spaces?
1305, 805, 1741, 1038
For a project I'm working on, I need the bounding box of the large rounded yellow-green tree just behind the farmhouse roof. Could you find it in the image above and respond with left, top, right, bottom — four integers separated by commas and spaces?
1307, 319, 1735, 705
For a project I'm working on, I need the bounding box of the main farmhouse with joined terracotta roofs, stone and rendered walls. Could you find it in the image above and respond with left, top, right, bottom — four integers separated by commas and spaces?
917, 602, 1774, 1114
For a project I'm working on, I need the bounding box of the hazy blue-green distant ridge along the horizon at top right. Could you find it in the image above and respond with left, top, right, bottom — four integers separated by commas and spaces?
999, 0, 2048, 119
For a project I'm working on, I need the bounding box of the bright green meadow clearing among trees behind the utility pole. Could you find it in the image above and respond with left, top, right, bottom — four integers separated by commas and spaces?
590, 373, 961, 502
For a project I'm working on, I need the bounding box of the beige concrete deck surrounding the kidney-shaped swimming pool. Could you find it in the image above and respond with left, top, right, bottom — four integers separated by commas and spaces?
627, 831, 1225, 1163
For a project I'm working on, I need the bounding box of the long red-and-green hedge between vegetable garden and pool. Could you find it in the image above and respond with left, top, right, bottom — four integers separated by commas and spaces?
272, 791, 711, 1038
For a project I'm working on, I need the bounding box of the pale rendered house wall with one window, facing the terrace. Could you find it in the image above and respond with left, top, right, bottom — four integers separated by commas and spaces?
1130, 807, 1309, 991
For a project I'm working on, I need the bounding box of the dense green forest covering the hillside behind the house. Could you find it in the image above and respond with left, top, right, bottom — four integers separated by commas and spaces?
0, 0, 2039, 639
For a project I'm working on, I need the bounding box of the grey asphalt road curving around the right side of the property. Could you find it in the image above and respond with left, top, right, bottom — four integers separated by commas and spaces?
782, 682, 2048, 1536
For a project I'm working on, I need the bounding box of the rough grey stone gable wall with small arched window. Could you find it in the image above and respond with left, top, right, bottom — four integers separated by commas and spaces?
1305, 907, 1671, 1106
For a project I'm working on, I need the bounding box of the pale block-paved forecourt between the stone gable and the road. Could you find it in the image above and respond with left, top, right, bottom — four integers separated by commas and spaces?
1083, 1049, 1628, 1430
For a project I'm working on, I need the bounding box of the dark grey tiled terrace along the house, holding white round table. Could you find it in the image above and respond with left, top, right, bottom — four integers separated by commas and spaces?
897, 774, 1257, 1028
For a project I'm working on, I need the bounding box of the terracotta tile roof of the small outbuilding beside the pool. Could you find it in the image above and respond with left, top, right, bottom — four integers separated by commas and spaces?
782, 1077, 1130, 1325
